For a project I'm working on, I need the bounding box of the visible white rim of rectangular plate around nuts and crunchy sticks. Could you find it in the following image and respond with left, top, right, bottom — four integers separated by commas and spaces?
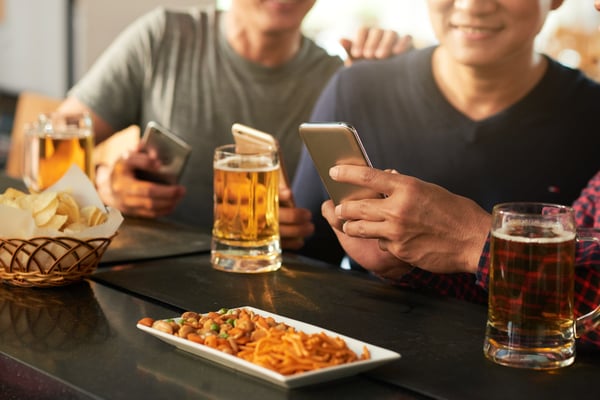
137, 306, 400, 388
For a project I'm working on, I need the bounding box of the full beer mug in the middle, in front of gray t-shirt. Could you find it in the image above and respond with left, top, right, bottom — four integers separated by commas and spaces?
211, 145, 281, 273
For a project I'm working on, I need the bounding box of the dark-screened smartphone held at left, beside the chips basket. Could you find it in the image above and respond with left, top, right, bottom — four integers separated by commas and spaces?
135, 121, 192, 185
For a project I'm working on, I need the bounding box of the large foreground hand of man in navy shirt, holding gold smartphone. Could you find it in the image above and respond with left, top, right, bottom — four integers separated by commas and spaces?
326, 165, 491, 273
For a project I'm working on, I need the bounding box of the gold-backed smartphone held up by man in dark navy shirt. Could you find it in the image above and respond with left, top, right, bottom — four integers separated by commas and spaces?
299, 122, 380, 204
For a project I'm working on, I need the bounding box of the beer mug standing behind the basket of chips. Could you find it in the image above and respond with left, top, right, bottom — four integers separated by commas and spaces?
23, 113, 94, 192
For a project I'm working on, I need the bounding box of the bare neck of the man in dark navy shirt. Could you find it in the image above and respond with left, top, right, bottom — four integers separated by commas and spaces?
433, 47, 547, 121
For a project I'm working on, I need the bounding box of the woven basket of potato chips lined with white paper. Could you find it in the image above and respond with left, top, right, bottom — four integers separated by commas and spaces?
0, 166, 122, 287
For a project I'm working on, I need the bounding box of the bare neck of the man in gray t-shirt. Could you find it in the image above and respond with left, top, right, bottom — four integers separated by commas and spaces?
225, 12, 302, 67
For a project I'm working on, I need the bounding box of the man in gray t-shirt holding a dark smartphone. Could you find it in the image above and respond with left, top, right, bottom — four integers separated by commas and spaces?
61, 0, 409, 244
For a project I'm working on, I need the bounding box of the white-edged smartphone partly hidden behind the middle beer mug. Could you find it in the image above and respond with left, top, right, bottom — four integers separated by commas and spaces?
231, 123, 294, 207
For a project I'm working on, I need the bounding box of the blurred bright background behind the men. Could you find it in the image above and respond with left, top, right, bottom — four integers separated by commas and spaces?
0, 0, 600, 167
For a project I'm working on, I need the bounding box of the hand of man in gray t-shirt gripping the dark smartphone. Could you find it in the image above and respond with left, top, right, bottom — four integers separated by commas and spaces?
96, 151, 185, 218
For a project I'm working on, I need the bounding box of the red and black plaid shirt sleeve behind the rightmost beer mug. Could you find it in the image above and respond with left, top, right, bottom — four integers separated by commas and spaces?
395, 172, 600, 348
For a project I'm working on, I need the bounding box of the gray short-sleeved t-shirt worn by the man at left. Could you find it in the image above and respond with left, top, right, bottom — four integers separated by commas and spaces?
69, 8, 342, 228
